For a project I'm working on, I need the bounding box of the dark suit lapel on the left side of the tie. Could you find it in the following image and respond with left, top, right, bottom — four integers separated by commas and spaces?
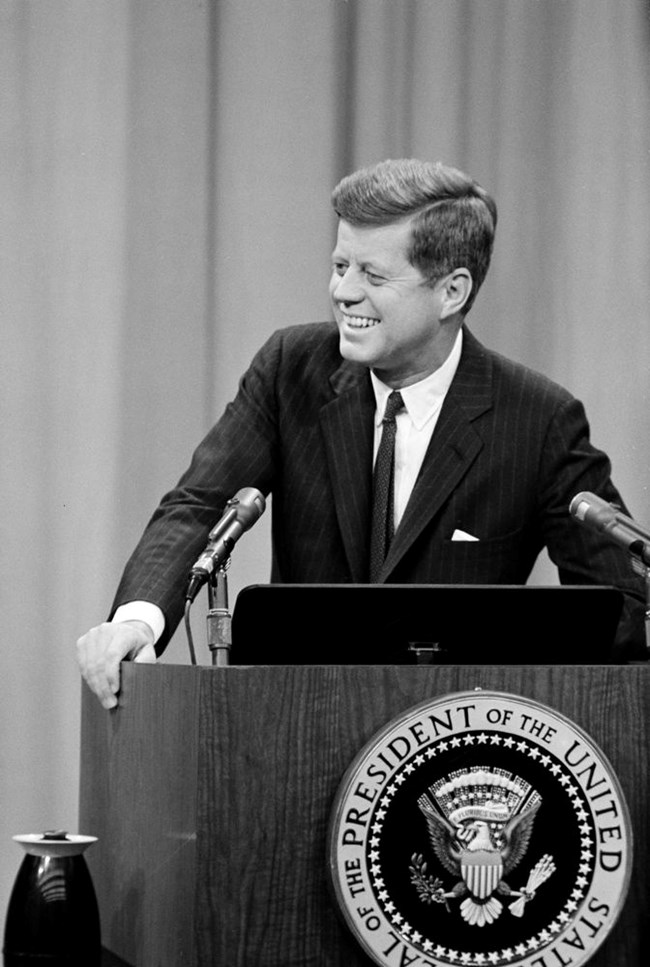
320, 361, 375, 583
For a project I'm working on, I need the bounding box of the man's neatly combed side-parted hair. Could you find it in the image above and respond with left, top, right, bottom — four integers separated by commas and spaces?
332, 158, 497, 313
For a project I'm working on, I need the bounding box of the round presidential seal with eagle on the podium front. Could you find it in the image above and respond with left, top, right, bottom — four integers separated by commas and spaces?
329, 690, 632, 967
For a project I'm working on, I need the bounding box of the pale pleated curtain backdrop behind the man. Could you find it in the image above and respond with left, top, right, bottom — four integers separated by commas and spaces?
0, 0, 650, 928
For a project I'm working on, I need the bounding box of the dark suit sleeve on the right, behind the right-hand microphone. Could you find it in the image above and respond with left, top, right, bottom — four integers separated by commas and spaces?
539, 398, 647, 660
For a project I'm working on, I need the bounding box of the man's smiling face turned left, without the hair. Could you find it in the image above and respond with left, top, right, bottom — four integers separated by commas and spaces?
330, 220, 450, 387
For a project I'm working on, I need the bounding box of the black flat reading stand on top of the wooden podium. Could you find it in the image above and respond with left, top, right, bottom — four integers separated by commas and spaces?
230, 584, 623, 665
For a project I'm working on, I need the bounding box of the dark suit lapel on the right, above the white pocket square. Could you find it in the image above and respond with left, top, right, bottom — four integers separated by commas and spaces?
380, 329, 492, 581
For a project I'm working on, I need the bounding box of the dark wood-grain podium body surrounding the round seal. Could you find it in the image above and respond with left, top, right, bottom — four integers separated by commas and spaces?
79, 663, 650, 967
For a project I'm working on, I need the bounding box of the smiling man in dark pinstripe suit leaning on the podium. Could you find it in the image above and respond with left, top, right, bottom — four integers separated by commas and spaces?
78, 160, 644, 708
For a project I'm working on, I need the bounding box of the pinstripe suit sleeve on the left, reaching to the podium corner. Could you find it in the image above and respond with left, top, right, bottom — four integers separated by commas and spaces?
111, 333, 281, 654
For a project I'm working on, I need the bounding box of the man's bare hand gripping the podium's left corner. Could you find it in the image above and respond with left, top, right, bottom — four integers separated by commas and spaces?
77, 621, 156, 708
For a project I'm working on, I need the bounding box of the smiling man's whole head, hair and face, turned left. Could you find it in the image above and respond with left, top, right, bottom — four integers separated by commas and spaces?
330, 161, 497, 387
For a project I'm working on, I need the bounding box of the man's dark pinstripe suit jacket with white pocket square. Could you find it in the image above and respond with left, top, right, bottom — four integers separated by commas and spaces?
115, 323, 643, 650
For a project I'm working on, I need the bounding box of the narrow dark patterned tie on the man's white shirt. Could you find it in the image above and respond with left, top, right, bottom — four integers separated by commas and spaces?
370, 391, 404, 583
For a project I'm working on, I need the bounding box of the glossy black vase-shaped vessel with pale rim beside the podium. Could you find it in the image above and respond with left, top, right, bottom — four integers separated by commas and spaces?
3, 833, 101, 967
